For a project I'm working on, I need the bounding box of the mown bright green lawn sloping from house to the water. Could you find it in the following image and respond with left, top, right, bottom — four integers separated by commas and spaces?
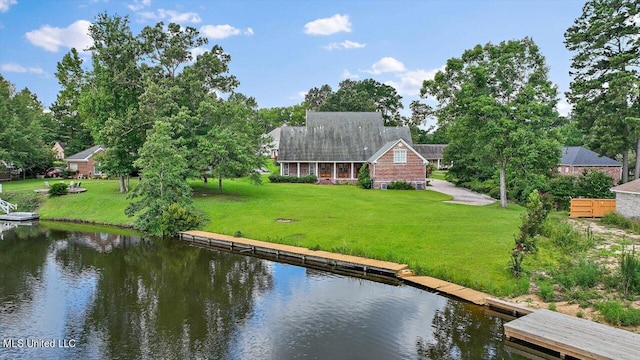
3, 178, 528, 295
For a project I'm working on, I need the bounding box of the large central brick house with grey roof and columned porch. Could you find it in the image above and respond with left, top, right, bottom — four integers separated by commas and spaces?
278, 112, 428, 188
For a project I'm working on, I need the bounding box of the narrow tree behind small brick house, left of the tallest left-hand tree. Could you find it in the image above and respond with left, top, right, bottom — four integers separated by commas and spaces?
51, 48, 95, 154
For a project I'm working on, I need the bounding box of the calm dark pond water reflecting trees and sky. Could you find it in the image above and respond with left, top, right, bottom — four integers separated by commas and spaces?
0, 225, 518, 359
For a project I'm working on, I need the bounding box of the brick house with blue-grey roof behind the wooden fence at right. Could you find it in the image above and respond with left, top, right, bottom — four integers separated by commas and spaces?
557, 146, 622, 184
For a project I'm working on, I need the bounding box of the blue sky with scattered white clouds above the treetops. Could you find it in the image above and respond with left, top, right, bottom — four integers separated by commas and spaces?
0, 0, 584, 115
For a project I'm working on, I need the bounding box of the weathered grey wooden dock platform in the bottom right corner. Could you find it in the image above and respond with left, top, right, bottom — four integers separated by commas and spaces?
504, 309, 640, 360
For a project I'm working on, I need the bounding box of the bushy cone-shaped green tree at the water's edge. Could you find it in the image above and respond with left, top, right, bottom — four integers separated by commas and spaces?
125, 121, 202, 236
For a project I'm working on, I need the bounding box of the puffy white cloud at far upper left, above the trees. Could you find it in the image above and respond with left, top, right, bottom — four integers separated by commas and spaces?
25, 20, 93, 52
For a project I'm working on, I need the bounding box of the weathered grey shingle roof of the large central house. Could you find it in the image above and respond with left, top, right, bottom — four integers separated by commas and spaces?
278, 112, 413, 162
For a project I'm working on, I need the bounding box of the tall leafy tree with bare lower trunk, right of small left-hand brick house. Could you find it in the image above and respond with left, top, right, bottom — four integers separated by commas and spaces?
79, 13, 144, 192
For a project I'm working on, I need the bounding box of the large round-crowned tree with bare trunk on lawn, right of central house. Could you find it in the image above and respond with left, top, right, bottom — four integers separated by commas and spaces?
421, 38, 560, 207
